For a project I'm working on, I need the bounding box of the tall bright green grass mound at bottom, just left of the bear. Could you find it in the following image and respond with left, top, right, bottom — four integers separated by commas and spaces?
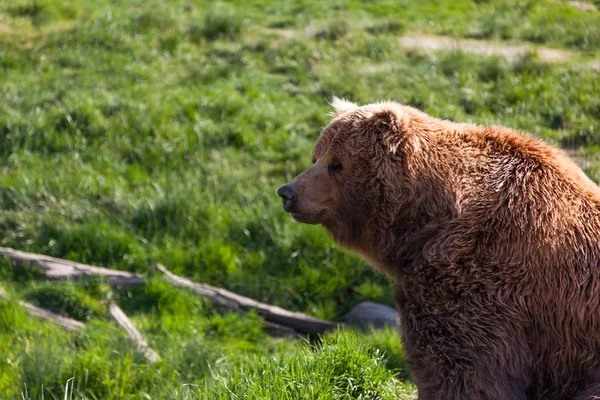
199, 332, 414, 400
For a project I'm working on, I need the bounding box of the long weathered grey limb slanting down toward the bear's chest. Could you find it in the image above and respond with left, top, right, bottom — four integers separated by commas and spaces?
156, 264, 340, 334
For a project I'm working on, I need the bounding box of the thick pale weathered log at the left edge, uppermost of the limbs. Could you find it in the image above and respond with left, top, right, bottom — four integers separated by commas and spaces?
0, 247, 143, 287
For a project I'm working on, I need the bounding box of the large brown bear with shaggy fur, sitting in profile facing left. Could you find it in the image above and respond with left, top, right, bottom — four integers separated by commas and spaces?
278, 100, 600, 400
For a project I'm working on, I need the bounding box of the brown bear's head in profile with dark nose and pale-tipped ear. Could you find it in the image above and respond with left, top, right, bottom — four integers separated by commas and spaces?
277, 98, 419, 253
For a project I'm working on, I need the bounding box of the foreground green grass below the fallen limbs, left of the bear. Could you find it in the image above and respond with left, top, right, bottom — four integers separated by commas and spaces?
0, 281, 413, 399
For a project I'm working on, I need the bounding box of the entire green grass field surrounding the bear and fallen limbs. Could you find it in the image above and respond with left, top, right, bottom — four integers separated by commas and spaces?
0, 0, 600, 399
